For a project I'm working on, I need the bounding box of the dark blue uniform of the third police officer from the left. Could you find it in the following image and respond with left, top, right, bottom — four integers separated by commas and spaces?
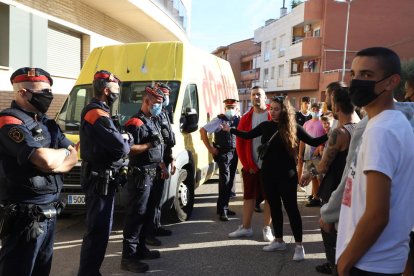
122, 111, 165, 259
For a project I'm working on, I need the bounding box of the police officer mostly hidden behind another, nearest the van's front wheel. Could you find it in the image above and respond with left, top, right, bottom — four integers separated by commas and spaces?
145, 83, 176, 246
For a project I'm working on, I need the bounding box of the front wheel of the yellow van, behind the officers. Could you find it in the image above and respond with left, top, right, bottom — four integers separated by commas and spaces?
173, 168, 194, 222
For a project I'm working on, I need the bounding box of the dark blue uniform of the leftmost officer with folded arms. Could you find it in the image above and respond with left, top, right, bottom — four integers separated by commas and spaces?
0, 102, 72, 276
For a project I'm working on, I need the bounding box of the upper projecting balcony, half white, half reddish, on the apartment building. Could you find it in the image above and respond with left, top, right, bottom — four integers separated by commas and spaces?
288, 37, 321, 59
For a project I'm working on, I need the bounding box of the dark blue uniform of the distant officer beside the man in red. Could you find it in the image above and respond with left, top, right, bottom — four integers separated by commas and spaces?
214, 114, 240, 216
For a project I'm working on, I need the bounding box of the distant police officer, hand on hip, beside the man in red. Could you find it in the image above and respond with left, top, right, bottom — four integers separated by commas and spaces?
200, 99, 240, 221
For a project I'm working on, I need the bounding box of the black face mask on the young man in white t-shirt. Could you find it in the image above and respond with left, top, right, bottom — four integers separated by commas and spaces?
349, 76, 390, 107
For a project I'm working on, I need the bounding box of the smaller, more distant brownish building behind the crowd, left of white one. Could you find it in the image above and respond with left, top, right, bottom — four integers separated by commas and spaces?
212, 38, 260, 113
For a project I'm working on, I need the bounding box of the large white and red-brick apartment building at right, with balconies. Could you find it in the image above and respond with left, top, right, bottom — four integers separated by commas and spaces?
254, 0, 414, 108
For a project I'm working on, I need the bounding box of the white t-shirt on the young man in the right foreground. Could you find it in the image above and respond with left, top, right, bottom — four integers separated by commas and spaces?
336, 110, 414, 273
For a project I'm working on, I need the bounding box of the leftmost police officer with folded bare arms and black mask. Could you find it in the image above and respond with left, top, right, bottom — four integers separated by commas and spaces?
0, 67, 78, 276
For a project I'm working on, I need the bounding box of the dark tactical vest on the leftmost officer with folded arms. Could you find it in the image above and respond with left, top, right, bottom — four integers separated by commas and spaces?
0, 108, 63, 202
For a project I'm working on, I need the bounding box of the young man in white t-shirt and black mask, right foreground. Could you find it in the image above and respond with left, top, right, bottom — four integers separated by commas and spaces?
336, 47, 414, 275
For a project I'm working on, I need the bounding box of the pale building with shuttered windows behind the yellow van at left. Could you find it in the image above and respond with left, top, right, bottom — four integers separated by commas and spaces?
0, 0, 191, 115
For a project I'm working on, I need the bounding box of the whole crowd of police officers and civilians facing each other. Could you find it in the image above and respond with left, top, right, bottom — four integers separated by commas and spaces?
0, 47, 414, 276
